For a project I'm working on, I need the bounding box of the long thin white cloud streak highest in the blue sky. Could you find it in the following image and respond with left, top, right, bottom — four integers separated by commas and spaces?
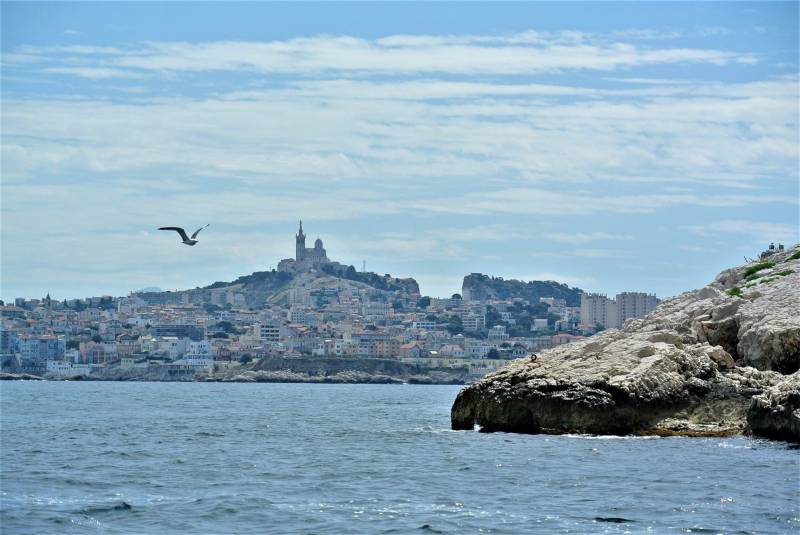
14, 31, 756, 75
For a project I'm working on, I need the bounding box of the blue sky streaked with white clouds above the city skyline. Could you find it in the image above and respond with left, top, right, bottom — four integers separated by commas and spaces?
0, 1, 800, 300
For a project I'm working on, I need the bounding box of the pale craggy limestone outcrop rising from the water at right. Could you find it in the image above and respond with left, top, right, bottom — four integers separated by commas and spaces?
451, 245, 800, 441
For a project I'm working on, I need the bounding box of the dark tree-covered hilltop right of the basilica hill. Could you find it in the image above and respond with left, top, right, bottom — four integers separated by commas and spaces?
461, 273, 581, 307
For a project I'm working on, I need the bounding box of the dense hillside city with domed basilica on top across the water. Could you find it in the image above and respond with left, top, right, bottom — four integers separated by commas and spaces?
1, 222, 659, 384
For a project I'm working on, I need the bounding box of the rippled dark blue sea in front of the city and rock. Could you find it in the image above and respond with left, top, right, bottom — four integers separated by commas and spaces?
0, 382, 800, 534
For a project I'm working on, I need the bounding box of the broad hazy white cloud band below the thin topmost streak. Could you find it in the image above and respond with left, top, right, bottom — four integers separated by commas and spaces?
3, 73, 797, 191
